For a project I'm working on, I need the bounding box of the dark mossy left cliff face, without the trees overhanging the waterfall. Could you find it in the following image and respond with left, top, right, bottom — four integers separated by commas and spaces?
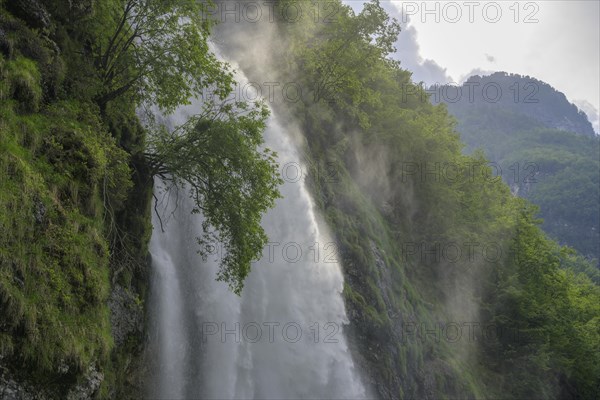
0, 0, 152, 399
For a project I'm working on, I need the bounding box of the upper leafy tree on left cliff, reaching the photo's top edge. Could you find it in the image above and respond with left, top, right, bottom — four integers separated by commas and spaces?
93, 0, 233, 112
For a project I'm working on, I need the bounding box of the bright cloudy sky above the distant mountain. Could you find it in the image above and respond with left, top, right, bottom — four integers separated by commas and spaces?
344, 0, 600, 133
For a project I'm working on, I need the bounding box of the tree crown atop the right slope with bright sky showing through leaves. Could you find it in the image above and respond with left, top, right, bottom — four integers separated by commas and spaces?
292, 0, 400, 126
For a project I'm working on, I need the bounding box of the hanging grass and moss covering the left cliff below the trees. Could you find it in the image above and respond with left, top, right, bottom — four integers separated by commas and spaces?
0, 91, 129, 387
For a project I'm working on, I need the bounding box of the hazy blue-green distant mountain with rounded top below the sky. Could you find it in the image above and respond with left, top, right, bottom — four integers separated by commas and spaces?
438, 72, 600, 259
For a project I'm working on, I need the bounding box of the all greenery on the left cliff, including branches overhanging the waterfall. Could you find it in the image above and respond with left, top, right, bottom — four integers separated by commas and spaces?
0, 0, 280, 398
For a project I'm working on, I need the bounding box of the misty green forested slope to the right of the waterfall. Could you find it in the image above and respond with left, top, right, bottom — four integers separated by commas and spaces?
217, 1, 600, 398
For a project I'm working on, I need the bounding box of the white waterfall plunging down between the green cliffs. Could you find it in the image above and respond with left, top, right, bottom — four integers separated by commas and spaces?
149, 54, 365, 399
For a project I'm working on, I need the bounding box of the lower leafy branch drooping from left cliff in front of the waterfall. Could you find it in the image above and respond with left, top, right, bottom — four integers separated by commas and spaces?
146, 102, 283, 294
